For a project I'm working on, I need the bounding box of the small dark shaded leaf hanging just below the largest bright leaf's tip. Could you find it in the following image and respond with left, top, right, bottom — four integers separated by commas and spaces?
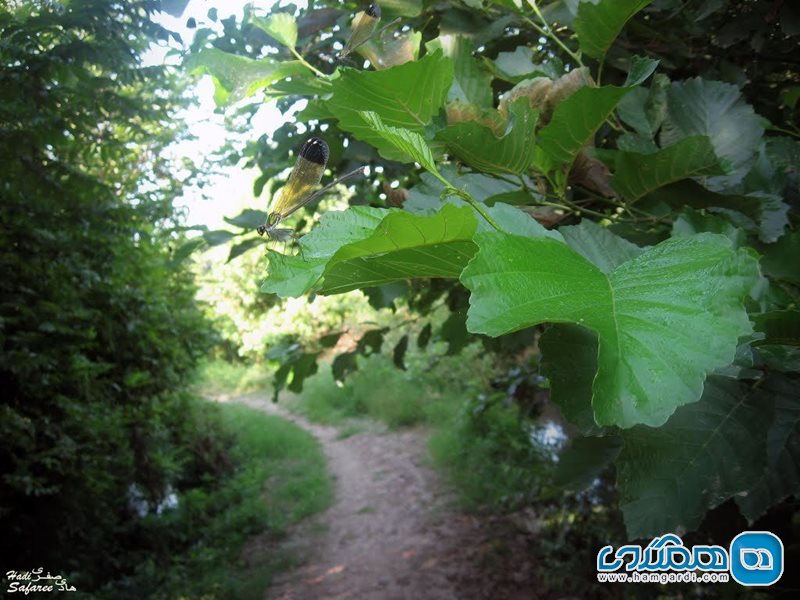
553, 435, 623, 492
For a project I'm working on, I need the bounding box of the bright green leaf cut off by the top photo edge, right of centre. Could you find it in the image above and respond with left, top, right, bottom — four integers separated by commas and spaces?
572, 0, 653, 62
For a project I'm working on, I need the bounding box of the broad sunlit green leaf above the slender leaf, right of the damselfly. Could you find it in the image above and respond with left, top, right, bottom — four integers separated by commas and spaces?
326, 51, 453, 160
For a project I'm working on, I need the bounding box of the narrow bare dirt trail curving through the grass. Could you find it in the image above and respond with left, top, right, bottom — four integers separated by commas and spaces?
230, 393, 532, 600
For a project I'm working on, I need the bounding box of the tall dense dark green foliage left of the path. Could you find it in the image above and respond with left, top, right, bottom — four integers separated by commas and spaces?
0, 0, 216, 590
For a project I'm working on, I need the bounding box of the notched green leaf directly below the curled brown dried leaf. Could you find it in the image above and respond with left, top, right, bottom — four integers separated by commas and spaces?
436, 98, 539, 175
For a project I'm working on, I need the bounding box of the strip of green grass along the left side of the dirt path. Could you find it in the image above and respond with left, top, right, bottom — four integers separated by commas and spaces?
100, 402, 333, 600
